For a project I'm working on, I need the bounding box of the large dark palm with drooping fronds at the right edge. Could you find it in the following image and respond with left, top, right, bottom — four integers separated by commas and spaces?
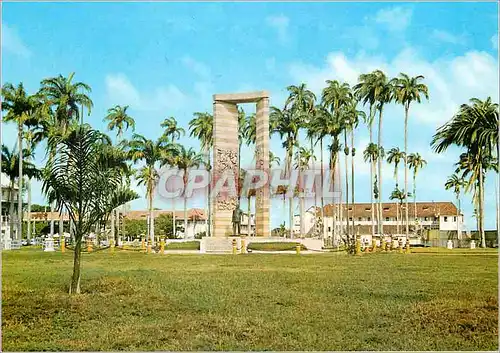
431, 97, 500, 247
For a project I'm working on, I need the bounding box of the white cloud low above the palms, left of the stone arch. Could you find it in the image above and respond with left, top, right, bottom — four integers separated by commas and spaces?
106, 73, 188, 111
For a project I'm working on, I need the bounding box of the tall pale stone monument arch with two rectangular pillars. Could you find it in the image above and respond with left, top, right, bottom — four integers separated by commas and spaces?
212, 91, 270, 237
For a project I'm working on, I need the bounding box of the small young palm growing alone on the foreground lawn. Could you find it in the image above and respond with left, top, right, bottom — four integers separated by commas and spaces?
42, 125, 138, 294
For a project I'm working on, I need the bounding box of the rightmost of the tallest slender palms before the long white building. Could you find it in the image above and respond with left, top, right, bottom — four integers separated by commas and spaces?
392, 73, 429, 239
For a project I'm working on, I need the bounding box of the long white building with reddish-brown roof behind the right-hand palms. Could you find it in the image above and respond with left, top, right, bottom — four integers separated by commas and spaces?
293, 202, 465, 244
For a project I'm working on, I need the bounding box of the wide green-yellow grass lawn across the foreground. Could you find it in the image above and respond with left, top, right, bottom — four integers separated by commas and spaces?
2, 246, 498, 351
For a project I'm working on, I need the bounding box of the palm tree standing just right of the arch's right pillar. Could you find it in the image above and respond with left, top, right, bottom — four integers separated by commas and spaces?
269, 107, 304, 236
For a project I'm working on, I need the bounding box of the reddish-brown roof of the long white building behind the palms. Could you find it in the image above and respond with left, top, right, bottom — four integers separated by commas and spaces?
314, 202, 458, 218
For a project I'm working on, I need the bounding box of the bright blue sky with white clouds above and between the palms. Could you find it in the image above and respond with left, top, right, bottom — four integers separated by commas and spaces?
1, 2, 499, 229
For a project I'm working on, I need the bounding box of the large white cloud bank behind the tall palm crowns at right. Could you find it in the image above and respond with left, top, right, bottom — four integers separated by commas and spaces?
289, 48, 498, 127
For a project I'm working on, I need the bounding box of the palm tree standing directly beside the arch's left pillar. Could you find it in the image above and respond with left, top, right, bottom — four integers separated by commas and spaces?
188, 112, 214, 236
